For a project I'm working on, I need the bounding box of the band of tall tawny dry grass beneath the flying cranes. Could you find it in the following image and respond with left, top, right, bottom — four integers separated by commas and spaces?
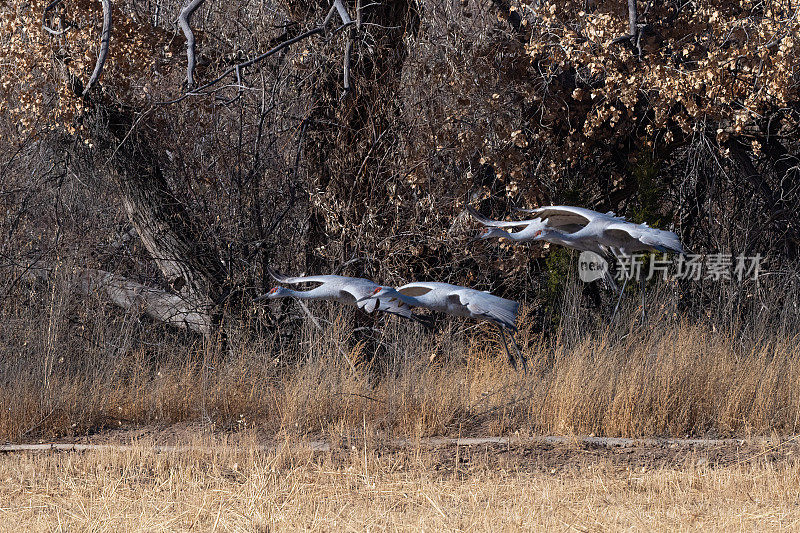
0, 270, 800, 441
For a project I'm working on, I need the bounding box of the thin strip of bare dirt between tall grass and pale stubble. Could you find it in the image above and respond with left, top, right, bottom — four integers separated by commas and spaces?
7, 424, 800, 475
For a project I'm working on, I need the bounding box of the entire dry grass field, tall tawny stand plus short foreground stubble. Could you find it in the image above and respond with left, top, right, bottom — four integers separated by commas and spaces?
0, 280, 800, 531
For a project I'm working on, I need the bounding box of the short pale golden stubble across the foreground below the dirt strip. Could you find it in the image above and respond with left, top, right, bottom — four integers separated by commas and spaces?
0, 436, 800, 532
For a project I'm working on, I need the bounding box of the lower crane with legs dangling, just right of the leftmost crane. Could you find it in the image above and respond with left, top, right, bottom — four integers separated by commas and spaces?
365, 281, 528, 372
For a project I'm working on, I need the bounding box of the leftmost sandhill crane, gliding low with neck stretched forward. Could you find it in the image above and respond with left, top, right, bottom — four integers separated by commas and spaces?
253, 270, 431, 328
